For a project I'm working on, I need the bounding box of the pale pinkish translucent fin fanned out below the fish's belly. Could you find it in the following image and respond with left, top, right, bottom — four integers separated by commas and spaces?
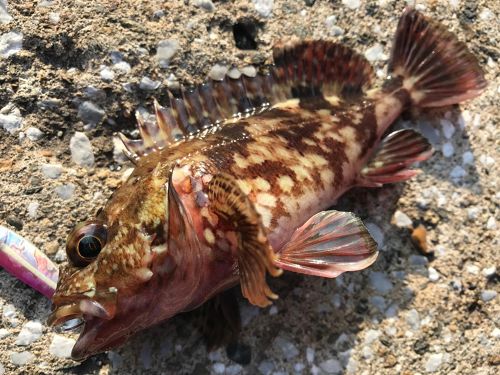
275, 210, 378, 278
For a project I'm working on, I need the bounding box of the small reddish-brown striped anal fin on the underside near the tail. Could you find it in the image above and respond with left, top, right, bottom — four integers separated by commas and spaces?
358, 129, 433, 187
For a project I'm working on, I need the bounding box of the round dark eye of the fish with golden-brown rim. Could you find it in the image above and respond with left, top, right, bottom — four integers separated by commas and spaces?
66, 221, 107, 267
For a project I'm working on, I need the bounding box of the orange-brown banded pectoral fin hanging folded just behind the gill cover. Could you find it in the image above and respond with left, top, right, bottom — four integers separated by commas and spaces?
208, 174, 281, 307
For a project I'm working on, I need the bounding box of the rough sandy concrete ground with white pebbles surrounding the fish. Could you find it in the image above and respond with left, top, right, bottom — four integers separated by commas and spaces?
0, 0, 500, 374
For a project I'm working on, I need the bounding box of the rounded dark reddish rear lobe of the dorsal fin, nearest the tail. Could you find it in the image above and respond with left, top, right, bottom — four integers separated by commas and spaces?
273, 39, 373, 99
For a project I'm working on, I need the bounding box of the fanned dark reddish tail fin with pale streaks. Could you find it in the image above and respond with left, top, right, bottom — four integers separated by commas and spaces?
389, 8, 486, 107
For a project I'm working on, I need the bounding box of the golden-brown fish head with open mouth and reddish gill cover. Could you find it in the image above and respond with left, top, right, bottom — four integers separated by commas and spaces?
49, 167, 200, 360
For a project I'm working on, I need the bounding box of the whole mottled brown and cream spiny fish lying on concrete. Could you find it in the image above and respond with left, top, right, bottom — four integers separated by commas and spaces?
48, 8, 487, 360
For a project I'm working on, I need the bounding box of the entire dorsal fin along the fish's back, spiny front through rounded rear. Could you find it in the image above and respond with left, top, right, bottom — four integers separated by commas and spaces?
118, 41, 373, 161
